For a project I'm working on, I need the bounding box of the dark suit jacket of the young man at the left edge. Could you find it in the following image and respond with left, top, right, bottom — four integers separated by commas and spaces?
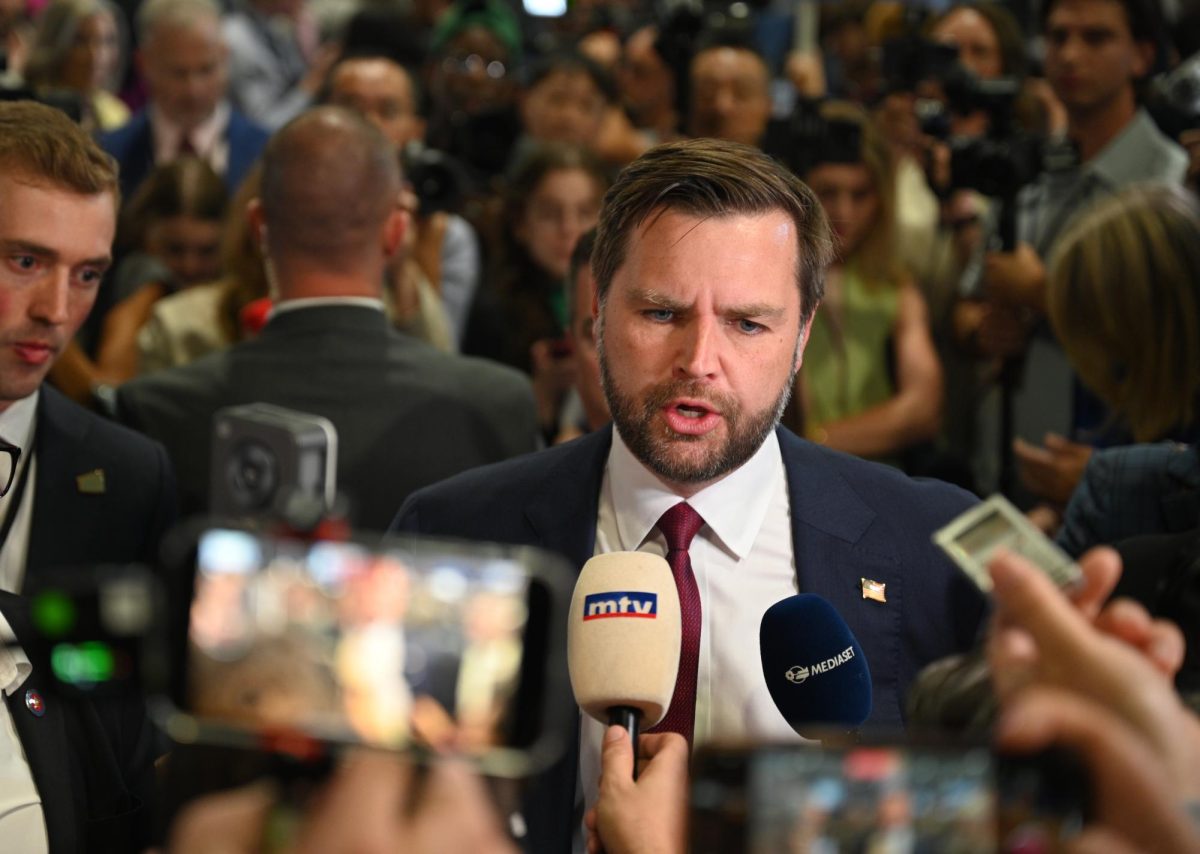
0, 385, 175, 854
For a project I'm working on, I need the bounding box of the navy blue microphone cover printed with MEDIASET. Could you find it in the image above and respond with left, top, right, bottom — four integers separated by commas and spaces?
758, 594, 871, 736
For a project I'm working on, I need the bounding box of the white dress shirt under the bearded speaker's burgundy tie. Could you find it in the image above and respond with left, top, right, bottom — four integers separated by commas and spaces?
580, 429, 799, 807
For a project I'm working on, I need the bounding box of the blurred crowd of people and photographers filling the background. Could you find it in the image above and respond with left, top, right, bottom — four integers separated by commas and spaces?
0, 0, 1200, 506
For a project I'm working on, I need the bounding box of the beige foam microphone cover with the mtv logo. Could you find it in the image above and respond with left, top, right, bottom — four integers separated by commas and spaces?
566, 552, 680, 728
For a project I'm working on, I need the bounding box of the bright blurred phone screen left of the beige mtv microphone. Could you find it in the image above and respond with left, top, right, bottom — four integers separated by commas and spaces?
165, 529, 571, 772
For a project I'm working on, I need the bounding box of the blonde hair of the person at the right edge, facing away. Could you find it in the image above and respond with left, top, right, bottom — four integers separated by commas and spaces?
1046, 186, 1200, 441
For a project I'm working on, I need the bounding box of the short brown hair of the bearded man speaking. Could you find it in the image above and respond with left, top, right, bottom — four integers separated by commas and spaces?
592, 139, 833, 321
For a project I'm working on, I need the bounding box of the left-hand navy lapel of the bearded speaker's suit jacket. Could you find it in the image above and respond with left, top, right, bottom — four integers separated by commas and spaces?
526, 425, 612, 571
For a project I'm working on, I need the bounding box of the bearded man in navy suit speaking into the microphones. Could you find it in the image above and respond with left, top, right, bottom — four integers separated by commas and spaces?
395, 139, 985, 850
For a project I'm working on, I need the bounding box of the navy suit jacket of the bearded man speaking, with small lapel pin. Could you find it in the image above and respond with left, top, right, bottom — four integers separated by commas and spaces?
394, 427, 986, 850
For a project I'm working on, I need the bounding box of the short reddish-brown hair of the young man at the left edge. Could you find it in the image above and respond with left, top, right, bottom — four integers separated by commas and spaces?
0, 101, 120, 197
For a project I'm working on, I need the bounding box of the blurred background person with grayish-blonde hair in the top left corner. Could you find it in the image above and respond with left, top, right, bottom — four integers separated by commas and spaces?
25, 0, 130, 132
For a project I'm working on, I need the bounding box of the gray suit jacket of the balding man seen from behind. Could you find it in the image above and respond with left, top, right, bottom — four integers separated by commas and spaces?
116, 306, 538, 530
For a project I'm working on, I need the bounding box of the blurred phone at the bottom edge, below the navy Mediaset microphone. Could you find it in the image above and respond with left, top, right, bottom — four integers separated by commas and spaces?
692, 745, 1085, 854
